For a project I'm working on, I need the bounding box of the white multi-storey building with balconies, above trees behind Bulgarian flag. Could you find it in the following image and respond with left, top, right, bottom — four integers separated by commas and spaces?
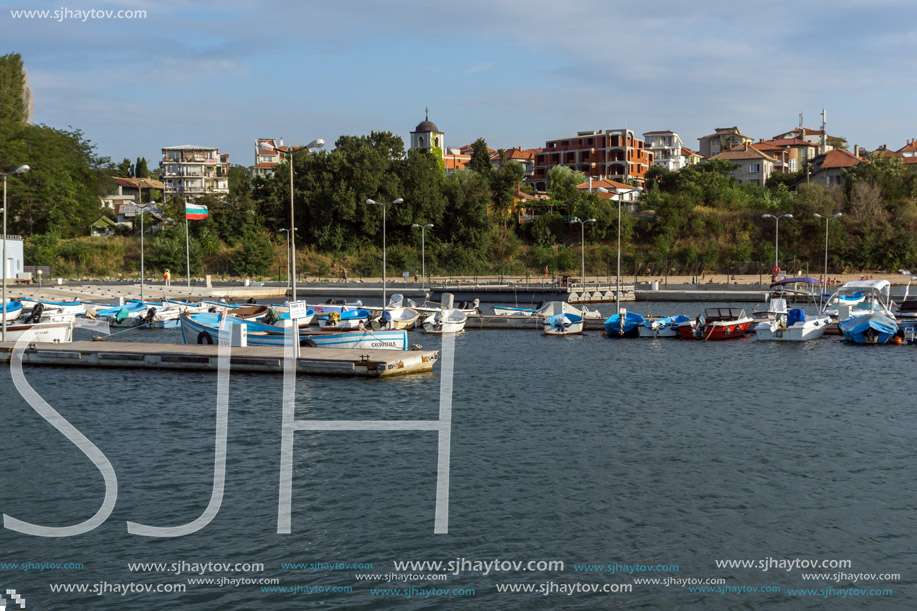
159, 144, 229, 199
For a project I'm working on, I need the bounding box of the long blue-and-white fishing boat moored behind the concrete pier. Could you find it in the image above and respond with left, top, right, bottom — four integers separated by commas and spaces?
180, 312, 408, 350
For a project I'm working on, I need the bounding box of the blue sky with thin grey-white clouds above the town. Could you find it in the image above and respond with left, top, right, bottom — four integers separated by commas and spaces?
0, 0, 917, 168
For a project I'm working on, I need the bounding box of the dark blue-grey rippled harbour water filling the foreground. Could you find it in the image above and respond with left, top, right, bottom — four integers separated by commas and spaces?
0, 304, 917, 610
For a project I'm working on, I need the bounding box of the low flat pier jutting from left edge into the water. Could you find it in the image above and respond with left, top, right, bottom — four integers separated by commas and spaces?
0, 342, 439, 377
